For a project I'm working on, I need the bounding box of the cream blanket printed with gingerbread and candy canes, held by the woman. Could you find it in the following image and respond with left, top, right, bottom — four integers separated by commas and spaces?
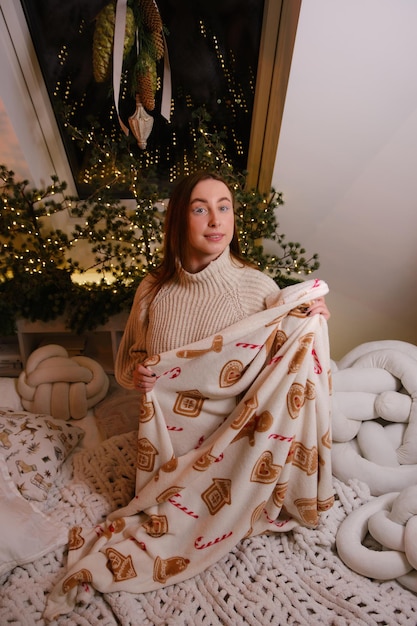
45, 280, 333, 619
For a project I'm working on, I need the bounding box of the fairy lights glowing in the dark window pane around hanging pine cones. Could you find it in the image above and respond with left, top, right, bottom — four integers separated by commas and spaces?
48, 3, 256, 189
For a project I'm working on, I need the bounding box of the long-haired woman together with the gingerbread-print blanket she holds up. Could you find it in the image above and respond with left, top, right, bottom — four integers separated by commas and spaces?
45, 173, 334, 619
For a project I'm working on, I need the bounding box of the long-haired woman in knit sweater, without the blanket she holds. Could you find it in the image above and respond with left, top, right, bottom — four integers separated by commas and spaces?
115, 171, 330, 393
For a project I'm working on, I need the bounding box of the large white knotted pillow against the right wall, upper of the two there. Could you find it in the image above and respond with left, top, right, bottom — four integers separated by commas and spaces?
332, 341, 417, 495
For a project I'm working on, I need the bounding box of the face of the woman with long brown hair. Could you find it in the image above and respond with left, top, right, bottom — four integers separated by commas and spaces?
183, 178, 235, 273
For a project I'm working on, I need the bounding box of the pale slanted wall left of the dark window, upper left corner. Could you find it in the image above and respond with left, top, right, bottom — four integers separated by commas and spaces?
0, 0, 76, 194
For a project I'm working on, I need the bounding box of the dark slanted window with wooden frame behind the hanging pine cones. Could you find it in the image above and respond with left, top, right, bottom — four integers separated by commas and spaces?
1, 0, 300, 195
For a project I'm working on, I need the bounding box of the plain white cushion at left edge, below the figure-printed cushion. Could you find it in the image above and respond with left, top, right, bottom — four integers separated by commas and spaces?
0, 454, 68, 576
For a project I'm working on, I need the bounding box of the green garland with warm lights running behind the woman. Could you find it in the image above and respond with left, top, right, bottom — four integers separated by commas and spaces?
0, 111, 319, 335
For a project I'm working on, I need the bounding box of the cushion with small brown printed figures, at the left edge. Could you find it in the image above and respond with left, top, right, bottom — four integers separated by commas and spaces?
0, 409, 84, 501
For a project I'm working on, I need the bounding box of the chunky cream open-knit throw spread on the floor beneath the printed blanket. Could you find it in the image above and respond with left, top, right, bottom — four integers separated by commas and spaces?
0, 433, 417, 626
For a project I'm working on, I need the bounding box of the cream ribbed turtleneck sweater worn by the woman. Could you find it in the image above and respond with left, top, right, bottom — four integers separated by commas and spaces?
115, 248, 279, 389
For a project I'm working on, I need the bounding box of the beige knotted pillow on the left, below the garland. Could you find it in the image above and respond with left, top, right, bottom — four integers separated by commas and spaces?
17, 344, 109, 420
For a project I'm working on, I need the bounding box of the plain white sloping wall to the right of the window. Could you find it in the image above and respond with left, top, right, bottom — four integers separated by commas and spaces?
273, 0, 417, 359
